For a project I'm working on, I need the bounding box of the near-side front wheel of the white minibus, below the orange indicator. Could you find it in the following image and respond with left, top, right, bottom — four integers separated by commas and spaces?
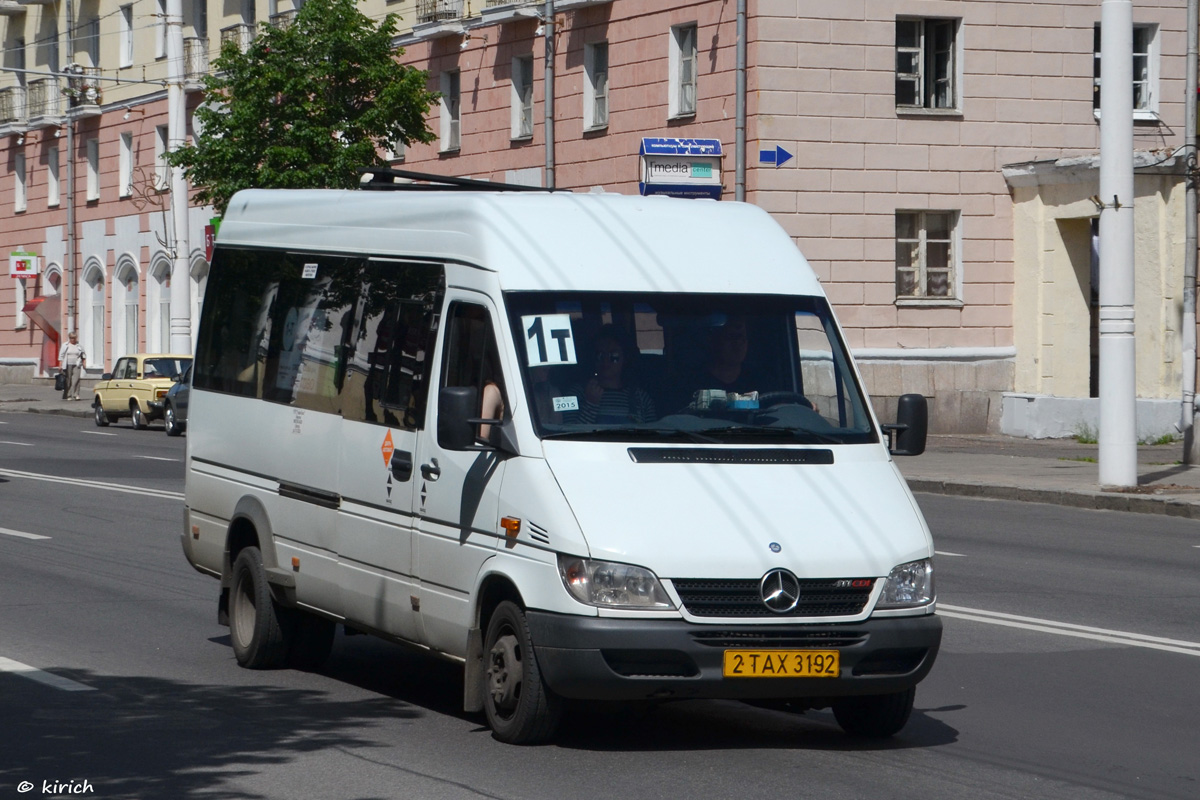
484, 600, 562, 745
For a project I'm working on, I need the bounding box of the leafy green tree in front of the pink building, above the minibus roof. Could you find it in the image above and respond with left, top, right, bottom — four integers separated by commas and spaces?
167, 0, 438, 213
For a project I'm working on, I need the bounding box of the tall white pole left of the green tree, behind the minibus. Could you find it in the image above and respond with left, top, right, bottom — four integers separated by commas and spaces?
167, 0, 192, 354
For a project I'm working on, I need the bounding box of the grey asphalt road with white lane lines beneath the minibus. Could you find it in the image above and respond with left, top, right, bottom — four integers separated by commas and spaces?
0, 414, 1200, 800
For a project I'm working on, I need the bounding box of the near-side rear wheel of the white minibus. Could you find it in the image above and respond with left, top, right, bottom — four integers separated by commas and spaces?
229, 547, 290, 669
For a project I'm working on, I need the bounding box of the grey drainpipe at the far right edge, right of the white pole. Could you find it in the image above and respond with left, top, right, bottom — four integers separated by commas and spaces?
1180, 0, 1200, 464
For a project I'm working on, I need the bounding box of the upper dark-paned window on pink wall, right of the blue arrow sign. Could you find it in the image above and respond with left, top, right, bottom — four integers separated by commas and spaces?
896, 18, 959, 110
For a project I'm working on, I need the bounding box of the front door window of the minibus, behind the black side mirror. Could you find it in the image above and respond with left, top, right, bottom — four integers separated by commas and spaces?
442, 302, 510, 438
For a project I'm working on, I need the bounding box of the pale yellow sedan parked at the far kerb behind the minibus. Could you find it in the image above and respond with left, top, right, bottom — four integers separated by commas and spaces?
91, 353, 192, 431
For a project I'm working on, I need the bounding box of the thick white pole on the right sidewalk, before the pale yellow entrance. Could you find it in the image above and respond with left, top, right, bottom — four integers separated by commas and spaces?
1099, 0, 1138, 486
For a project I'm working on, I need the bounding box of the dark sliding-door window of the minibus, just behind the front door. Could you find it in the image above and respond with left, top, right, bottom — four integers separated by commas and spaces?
337, 260, 445, 431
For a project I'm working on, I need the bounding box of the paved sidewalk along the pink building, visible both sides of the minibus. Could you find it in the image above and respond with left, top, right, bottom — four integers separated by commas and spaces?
0, 381, 1200, 519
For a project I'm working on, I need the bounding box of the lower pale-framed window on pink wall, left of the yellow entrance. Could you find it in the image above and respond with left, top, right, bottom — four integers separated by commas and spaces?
896, 211, 958, 301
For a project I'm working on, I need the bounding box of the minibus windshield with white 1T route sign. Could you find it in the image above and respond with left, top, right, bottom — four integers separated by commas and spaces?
505, 291, 878, 445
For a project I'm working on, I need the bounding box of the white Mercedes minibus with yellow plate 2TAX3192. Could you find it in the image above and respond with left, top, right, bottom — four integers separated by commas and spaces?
182, 170, 942, 744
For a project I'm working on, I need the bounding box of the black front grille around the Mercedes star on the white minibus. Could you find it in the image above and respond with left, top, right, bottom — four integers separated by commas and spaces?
672, 578, 875, 619
